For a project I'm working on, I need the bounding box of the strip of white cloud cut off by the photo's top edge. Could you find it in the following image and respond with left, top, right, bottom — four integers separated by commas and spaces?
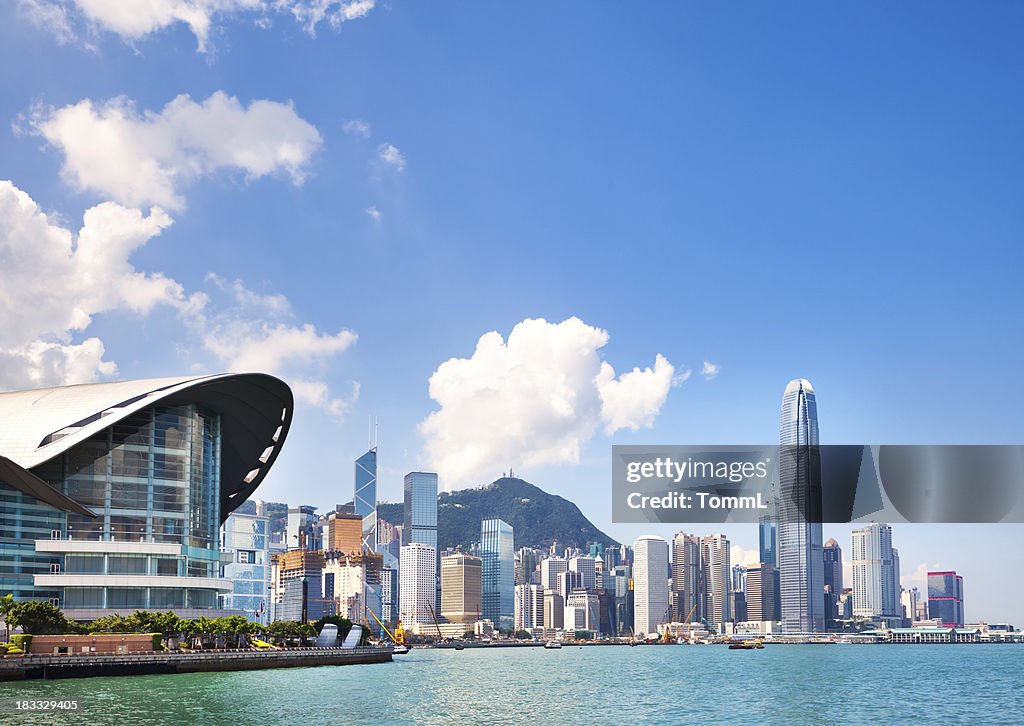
18, 0, 376, 52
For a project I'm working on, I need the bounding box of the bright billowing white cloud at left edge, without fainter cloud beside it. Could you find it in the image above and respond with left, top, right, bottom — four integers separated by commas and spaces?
0, 181, 194, 388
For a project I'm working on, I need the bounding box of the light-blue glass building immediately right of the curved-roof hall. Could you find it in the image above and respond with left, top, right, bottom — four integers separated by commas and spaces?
220, 500, 270, 625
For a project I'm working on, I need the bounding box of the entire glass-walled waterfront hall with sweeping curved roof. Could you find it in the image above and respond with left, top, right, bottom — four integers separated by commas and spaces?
0, 374, 293, 620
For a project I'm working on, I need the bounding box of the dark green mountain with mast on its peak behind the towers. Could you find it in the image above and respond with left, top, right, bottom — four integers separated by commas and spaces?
377, 477, 618, 549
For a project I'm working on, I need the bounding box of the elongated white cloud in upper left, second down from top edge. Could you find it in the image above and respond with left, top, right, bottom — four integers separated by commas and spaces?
30, 91, 322, 209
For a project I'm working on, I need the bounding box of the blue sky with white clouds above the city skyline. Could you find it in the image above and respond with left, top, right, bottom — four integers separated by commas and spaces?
0, 0, 1024, 624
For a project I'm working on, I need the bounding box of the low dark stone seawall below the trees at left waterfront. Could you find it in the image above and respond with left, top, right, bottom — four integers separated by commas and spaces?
0, 647, 391, 681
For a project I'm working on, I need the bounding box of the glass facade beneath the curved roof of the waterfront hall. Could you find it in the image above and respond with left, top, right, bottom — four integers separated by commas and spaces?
0, 404, 227, 609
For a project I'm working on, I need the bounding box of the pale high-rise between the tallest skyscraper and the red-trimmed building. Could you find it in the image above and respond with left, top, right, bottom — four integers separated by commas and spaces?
850, 522, 901, 618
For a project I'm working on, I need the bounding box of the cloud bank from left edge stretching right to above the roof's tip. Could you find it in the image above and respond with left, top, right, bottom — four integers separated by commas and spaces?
0, 181, 358, 415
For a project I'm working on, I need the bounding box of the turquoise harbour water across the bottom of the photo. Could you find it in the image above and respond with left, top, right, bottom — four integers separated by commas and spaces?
0, 645, 1024, 725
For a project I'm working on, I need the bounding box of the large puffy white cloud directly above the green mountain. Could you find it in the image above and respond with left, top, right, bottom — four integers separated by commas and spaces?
419, 317, 674, 487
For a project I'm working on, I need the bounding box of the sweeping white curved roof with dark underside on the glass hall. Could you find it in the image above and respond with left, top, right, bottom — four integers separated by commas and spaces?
0, 373, 294, 518
